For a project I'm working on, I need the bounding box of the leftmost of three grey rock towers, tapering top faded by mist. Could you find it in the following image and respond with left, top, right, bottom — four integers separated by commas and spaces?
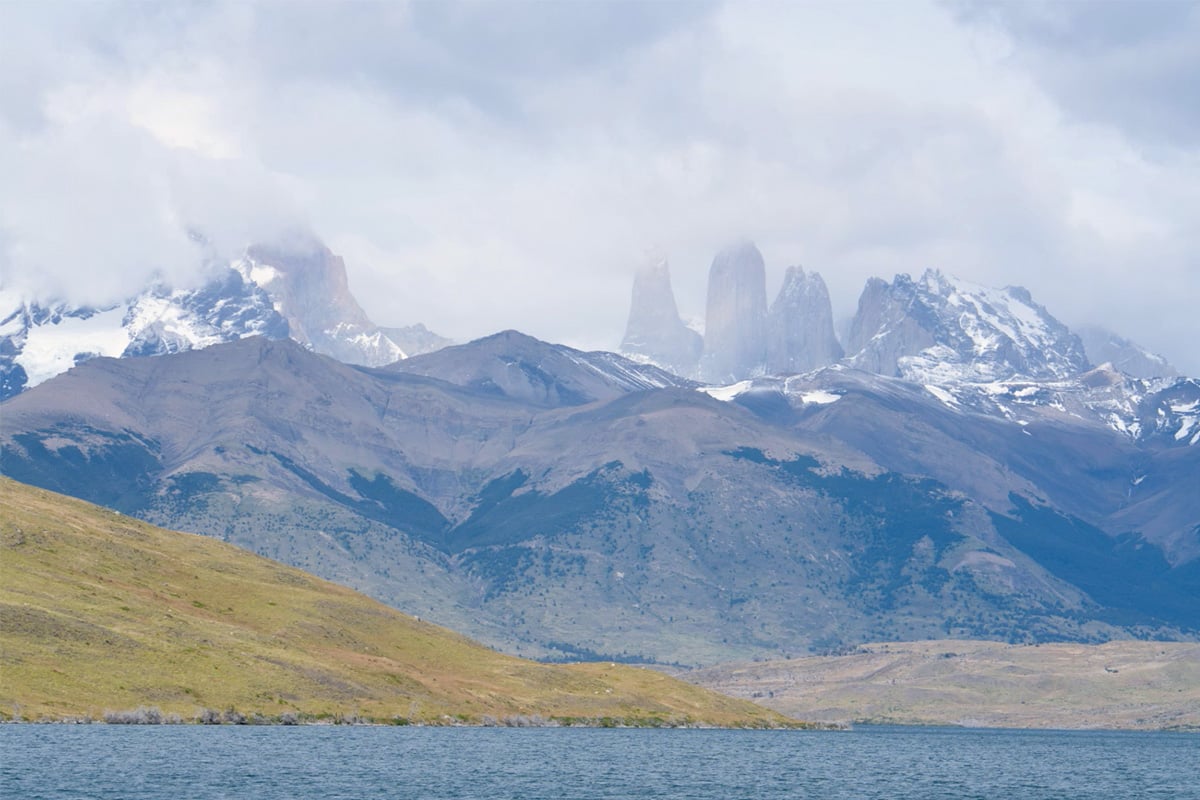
620, 258, 704, 375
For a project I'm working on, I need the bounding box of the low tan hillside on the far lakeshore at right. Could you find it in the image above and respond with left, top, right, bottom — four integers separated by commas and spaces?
686, 640, 1200, 730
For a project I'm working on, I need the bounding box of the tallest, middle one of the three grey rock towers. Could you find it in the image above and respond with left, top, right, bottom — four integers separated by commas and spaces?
700, 241, 767, 384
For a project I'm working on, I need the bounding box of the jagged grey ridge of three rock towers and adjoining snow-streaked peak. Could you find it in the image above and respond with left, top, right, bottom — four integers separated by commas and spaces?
620, 241, 1177, 384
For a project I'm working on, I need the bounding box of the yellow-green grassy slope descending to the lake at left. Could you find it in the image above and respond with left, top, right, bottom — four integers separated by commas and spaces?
0, 477, 791, 727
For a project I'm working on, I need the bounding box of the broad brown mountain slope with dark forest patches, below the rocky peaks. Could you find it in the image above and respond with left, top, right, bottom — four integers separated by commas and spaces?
0, 333, 1200, 664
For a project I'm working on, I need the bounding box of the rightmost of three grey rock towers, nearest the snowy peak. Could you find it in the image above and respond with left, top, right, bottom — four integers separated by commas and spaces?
767, 266, 844, 374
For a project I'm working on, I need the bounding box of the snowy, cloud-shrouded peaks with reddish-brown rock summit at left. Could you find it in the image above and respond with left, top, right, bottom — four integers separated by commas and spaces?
0, 237, 450, 399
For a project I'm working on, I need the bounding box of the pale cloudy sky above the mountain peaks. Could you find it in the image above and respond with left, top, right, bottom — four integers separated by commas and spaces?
0, 0, 1200, 375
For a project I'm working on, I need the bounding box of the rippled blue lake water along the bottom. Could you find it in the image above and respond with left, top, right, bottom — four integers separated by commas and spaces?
0, 724, 1200, 800
